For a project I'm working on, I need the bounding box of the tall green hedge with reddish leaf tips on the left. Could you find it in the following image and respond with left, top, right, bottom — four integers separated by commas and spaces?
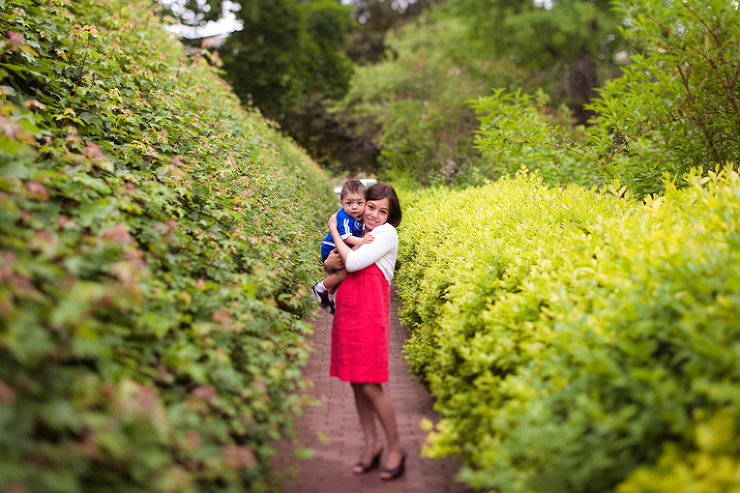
0, 0, 335, 493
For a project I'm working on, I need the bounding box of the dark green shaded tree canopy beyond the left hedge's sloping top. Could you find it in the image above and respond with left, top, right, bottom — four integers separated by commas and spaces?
211, 0, 353, 122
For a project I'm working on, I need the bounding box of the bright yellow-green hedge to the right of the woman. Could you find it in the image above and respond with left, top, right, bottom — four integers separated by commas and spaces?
397, 171, 740, 493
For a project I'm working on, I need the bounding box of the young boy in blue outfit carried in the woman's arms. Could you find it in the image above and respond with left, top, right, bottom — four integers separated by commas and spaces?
311, 180, 375, 313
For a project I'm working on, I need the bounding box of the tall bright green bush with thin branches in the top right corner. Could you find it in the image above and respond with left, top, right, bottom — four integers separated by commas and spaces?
591, 0, 740, 193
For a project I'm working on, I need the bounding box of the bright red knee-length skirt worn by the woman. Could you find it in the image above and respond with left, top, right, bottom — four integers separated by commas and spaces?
330, 264, 391, 383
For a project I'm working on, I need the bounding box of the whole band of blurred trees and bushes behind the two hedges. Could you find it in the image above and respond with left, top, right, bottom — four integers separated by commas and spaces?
162, 0, 738, 195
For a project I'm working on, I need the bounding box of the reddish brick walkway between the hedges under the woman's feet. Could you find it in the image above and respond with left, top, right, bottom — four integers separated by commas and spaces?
275, 294, 472, 493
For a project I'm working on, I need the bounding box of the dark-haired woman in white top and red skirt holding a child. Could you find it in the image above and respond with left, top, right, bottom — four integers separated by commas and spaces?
326, 183, 406, 480
